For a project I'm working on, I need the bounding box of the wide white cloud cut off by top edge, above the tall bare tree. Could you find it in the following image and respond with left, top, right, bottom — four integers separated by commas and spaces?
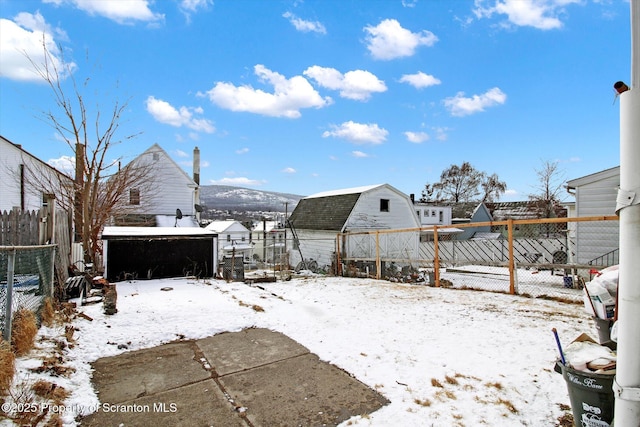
44, 0, 164, 24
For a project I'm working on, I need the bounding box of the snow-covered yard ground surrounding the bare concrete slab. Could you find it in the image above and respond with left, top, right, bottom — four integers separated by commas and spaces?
0, 276, 597, 426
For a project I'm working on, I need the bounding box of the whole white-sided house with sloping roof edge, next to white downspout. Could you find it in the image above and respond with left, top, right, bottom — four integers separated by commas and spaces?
567, 166, 620, 266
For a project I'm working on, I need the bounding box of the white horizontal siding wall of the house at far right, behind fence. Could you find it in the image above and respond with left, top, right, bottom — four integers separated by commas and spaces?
576, 175, 620, 264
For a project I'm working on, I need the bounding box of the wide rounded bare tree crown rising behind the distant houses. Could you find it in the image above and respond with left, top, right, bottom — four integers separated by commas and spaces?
420, 162, 507, 203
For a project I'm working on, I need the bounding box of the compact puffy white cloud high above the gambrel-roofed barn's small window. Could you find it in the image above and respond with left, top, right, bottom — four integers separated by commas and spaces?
364, 19, 438, 60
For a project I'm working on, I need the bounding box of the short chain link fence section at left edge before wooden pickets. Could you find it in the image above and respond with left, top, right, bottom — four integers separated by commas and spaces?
0, 245, 56, 340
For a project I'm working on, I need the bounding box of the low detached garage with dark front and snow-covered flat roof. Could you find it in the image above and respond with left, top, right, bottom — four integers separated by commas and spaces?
102, 227, 218, 282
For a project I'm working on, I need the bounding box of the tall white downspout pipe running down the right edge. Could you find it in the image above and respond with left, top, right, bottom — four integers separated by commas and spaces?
613, 0, 640, 427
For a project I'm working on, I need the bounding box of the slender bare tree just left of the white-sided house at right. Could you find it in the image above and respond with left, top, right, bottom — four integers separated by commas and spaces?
529, 160, 567, 218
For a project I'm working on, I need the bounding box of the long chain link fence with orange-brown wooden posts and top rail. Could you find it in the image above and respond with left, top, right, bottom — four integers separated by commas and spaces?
337, 216, 619, 301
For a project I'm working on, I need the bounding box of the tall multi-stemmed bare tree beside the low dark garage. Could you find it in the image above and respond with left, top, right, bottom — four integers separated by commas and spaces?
25, 38, 158, 262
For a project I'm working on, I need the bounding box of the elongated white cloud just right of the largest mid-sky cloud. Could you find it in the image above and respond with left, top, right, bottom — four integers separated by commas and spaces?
302, 65, 387, 101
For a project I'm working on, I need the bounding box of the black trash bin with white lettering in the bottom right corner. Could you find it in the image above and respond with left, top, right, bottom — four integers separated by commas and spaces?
555, 361, 615, 427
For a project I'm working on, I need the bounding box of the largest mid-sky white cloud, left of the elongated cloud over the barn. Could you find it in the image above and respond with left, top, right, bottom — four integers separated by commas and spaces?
207, 64, 333, 119
